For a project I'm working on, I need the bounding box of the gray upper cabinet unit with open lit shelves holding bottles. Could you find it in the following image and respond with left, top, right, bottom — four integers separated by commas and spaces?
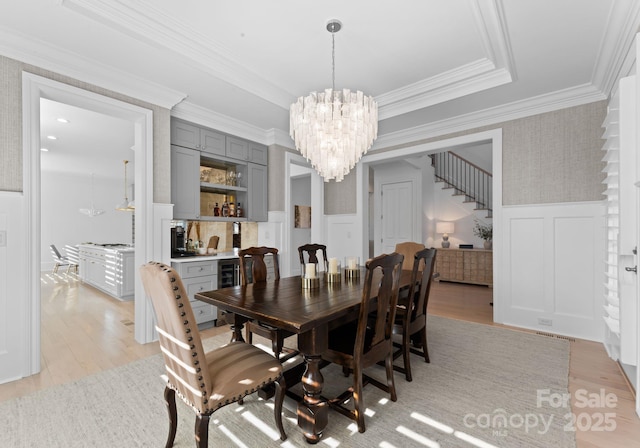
171, 119, 268, 221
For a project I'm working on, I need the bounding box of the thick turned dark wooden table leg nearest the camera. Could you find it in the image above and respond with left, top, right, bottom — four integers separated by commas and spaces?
298, 326, 329, 444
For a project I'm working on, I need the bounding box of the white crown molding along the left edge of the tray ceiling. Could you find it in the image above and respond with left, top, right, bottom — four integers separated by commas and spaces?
63, 0, 295, 109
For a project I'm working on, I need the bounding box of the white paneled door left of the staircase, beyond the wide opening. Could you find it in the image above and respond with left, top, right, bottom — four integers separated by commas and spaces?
376, 181, 416, 255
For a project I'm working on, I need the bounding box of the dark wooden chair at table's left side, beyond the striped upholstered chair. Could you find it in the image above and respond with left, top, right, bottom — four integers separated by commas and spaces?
238, 246, 298, 362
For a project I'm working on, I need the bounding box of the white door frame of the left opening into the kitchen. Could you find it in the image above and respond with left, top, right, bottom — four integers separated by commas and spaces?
20, 72, 154, 376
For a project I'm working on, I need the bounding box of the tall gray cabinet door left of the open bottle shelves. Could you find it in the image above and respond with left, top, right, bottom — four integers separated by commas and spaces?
171, 146, 200, 219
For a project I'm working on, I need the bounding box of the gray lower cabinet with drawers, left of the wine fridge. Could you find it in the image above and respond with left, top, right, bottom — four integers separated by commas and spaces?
171, 260, 218, 324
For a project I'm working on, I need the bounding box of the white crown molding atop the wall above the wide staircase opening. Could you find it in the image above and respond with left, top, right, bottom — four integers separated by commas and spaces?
371, 84, 607, 151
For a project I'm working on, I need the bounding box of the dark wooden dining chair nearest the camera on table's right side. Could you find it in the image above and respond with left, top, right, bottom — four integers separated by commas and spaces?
322, 252, 404, 432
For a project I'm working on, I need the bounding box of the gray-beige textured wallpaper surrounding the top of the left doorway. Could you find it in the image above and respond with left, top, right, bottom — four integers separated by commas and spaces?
0, 56, 171, 204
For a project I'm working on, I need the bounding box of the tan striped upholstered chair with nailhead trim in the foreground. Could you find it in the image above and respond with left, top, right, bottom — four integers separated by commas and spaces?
140, 262, 287, 448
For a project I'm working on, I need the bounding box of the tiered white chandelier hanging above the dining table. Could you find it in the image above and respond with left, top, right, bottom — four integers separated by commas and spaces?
289, 19, 378, 182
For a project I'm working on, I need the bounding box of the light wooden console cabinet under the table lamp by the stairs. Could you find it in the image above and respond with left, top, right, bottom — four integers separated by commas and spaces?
434, 249, 493, 286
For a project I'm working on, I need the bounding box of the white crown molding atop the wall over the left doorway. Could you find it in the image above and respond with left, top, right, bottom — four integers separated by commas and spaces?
0, 27, 187, 109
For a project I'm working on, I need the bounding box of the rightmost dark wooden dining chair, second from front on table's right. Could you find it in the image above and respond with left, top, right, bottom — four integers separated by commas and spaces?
393, 248, 436, 381
